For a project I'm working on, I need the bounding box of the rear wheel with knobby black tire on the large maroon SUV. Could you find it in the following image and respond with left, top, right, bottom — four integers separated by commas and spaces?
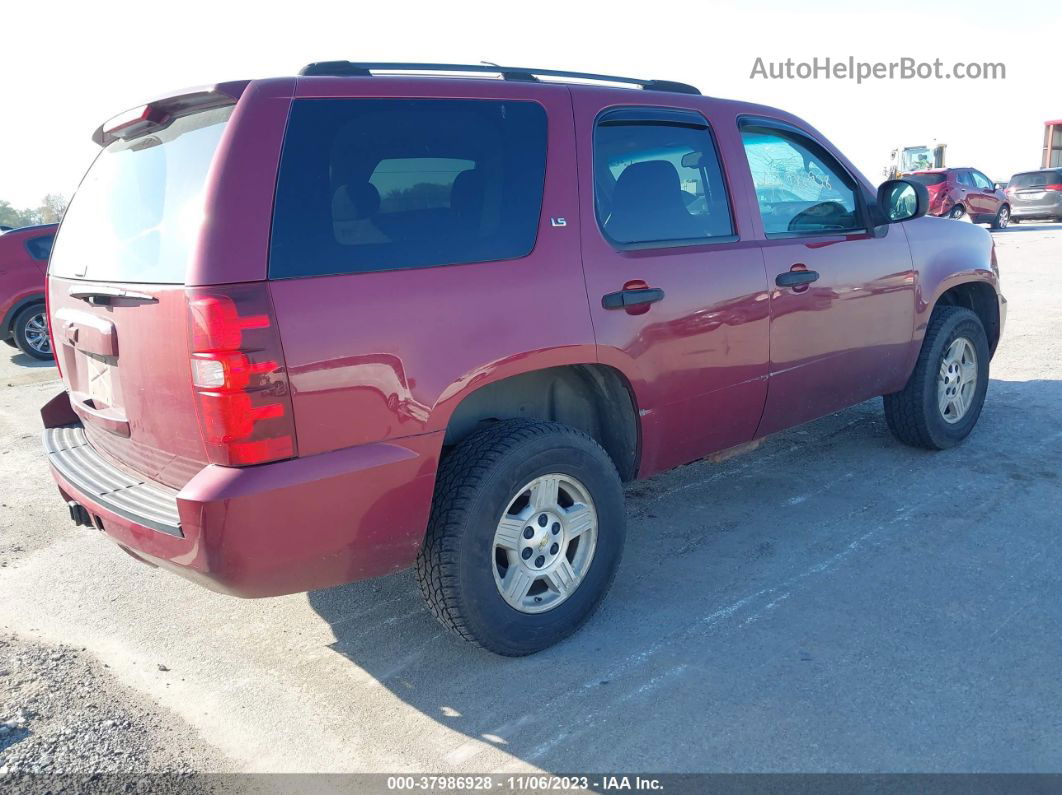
416, 419, 627, 657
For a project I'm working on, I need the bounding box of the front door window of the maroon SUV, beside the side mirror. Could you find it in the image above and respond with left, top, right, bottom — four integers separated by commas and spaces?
741, 124, 862, 236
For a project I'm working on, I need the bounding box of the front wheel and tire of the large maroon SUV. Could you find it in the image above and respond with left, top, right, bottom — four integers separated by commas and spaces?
884, 307, 990, 450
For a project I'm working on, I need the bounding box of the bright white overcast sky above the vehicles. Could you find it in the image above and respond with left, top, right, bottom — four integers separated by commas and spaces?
0, 0, 1062, 207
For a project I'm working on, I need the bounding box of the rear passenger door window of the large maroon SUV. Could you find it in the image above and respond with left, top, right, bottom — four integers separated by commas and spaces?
594, 120, 734, 244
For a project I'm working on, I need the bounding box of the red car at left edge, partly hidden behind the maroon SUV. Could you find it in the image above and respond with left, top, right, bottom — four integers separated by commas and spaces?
0, 224, 58, 359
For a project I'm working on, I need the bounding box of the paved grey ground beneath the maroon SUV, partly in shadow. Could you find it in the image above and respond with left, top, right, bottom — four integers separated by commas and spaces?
0, 219, 1062, 772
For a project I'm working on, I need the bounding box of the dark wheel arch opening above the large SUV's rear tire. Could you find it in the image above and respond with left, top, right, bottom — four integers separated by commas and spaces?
443, 362, 641, 481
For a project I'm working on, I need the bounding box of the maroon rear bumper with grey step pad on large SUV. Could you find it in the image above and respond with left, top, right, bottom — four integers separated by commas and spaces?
45, 425, 442, 597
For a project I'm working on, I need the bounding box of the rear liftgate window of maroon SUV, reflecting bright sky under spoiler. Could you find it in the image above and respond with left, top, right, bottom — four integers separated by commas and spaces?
49, 105, 233, 283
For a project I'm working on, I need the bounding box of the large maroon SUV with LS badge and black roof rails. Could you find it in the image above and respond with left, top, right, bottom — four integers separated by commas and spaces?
42, 62, 1006, 655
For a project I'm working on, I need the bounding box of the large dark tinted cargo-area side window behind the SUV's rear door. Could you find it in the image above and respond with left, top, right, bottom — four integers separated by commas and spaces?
269, 99, 546, 278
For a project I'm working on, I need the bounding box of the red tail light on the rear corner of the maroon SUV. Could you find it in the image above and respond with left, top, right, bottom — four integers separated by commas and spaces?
186, 282, 295, 466
